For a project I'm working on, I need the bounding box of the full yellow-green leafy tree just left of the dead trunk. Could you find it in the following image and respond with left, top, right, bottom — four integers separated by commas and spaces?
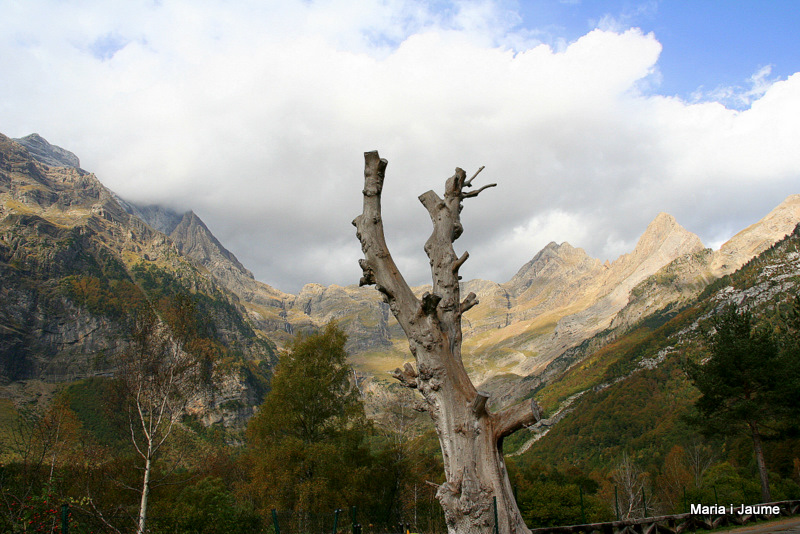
243, 324, 370, 520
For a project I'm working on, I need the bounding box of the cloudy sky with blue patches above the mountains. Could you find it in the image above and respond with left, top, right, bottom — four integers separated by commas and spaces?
0, 0, 800, 293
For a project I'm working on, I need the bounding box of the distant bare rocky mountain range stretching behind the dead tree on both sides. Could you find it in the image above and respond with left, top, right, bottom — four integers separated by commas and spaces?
144, 170, 800, 408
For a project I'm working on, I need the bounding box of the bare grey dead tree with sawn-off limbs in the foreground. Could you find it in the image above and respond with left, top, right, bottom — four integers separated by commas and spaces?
353, 152, 542, 534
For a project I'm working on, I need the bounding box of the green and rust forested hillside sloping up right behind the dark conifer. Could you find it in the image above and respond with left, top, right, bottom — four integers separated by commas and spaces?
506, 224, 800, 521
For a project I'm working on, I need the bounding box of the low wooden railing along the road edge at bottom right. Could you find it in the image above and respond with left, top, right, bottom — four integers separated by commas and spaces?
531, 500, 800, 534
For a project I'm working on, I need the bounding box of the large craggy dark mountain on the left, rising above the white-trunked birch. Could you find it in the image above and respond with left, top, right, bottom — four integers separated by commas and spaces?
0, 135, 276, 430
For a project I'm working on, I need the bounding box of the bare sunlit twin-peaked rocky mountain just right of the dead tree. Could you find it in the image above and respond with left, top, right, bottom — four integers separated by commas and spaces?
454, 213, 703, 389
